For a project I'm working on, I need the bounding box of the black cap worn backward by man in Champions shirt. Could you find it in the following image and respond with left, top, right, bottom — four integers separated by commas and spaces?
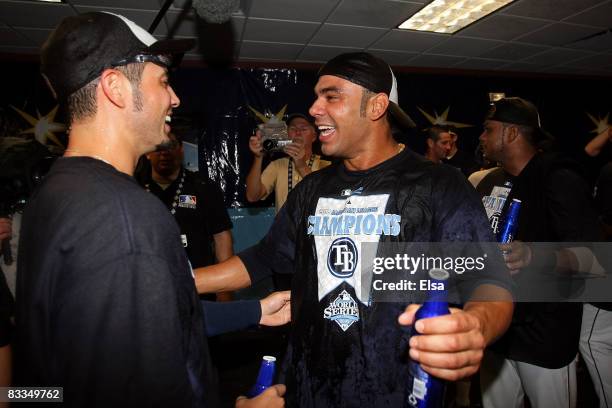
318, 52, 416, 129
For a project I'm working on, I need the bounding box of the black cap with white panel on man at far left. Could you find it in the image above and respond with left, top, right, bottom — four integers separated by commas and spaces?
41, 12, 195, 100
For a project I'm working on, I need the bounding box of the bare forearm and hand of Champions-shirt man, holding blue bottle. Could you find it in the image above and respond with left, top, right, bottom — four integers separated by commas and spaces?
399, 284, 514, 381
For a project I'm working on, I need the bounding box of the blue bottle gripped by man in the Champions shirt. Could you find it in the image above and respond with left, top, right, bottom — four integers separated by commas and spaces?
405, 268, 450, 408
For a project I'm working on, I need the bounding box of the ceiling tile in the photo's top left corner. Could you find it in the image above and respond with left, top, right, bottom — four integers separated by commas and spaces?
0, 1, 75, 28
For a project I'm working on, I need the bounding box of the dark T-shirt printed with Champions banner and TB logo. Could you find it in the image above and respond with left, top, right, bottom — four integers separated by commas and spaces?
239, 150, 511, 408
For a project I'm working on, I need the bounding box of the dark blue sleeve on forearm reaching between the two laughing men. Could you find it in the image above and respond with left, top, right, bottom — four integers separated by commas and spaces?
202, 300, 261, 337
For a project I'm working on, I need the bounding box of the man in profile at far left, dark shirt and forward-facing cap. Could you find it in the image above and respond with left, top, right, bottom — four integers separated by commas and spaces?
16, 13, 288, 407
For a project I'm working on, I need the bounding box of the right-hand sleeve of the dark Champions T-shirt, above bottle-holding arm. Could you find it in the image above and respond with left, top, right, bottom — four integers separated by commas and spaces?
433, 167, 514, 303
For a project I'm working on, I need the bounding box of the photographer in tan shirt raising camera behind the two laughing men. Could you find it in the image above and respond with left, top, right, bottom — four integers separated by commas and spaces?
246, 113, 330, 212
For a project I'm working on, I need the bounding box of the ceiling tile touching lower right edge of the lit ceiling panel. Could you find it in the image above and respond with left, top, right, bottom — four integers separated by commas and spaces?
457, 14, 543, 41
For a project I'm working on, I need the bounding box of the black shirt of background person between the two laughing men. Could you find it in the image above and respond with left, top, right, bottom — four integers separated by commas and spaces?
145, 169, 232, 268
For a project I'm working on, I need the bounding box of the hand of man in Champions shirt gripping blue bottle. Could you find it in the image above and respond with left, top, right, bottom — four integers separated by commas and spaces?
398, 304, 486, 381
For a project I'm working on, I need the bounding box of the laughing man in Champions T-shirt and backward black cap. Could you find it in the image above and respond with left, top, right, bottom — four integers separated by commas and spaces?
196, 53, 512, 408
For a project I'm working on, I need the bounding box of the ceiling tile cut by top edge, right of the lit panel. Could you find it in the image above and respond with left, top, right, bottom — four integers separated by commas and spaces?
501, 0, 602, 21
